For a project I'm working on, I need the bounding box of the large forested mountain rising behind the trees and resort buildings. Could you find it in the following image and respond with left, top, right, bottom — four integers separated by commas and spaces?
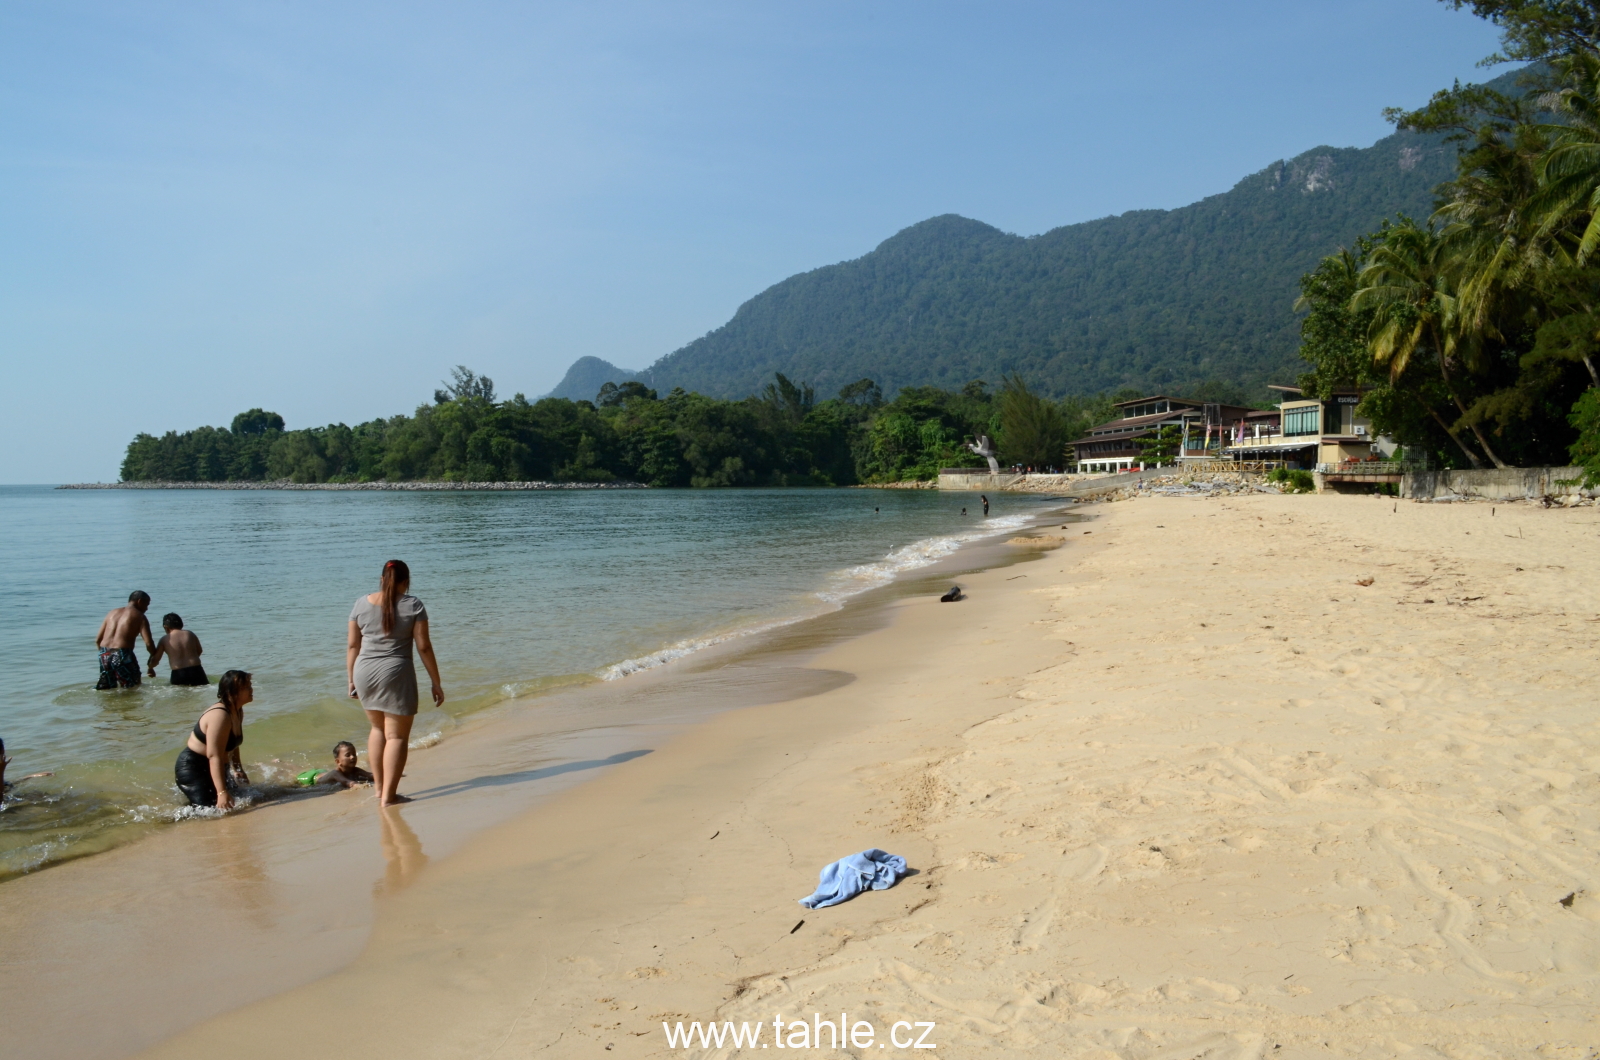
557, 111, 1478, 400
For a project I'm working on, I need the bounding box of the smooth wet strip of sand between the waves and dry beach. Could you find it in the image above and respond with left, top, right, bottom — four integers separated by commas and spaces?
9, 512, 1075, 1057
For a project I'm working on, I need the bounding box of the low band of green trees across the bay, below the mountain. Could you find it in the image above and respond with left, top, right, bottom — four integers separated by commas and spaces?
122, 367, 1114, 487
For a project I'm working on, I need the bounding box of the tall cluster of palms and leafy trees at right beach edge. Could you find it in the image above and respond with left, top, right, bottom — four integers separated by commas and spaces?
1299, 0, 1600, 480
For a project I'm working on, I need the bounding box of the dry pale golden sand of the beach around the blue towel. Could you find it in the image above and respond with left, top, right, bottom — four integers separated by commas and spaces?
21, 495, 1600, 1060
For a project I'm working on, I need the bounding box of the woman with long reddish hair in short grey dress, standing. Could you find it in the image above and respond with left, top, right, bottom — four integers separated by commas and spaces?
346, 559, 445, 805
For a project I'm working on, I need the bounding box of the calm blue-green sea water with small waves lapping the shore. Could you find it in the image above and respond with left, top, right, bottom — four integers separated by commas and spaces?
0, 487, 1045, 877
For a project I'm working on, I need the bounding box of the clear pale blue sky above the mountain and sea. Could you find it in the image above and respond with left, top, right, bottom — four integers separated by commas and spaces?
0, 0, 1496, 482
